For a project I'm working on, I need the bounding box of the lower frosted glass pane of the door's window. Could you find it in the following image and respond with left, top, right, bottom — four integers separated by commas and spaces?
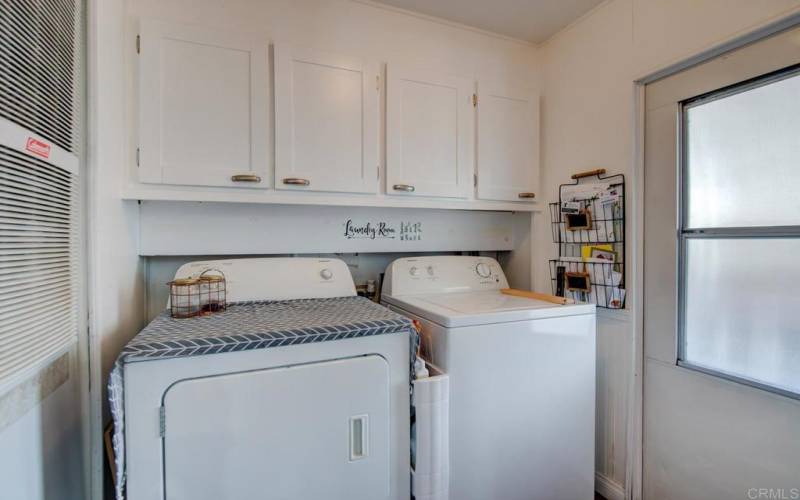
684, 238, 800, 394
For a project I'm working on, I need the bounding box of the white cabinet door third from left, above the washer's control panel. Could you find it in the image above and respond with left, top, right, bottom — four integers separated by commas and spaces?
386, 66, 475, 198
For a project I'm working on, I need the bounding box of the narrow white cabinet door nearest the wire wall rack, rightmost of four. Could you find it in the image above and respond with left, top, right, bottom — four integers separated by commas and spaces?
477, 82, 539, 202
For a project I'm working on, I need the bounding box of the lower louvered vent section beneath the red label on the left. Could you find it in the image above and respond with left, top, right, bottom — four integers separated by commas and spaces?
0, 145, 79, 381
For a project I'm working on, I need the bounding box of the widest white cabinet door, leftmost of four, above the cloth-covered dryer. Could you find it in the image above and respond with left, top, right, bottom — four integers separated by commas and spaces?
139, 21, 269, 188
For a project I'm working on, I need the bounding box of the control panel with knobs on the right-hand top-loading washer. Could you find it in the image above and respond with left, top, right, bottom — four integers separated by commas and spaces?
383, 255, 508, 295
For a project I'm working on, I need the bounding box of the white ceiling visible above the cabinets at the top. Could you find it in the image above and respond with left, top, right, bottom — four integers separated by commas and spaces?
377, 0, 603, 43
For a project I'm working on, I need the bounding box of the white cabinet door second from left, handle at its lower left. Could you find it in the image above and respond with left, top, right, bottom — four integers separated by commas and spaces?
275, 45, 378, 193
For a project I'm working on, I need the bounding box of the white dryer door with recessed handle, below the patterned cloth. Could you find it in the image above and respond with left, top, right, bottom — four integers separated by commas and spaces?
164, 355, 389, 500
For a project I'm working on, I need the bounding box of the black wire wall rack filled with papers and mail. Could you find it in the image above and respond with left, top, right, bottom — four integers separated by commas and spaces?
550, 169, 625, 309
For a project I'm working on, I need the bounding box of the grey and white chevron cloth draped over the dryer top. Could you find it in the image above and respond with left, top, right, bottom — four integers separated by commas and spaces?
108, 297, 419, 500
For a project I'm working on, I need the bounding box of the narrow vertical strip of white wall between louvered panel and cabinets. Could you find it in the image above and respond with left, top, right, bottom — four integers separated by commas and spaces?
87, 0, 144, 498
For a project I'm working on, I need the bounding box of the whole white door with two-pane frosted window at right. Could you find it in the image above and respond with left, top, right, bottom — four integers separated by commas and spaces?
643, 26, 800, 500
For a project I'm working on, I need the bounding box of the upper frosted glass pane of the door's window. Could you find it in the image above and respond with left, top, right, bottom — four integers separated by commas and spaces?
684, 74, 800, 228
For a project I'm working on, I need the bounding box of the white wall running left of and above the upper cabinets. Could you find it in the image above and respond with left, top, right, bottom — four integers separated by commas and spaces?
94, 0, 540, 491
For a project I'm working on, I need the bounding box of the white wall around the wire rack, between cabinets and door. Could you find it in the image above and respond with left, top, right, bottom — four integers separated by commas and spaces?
534, 0, 800, 494
